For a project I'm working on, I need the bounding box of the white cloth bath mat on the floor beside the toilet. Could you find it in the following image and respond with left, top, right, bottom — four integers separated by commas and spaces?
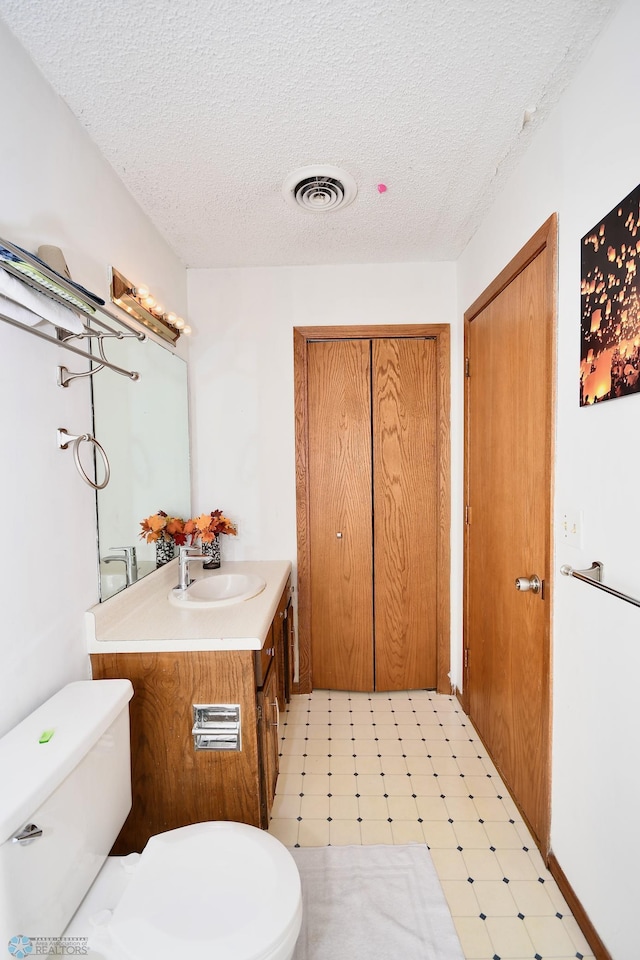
291, 844, 464, 960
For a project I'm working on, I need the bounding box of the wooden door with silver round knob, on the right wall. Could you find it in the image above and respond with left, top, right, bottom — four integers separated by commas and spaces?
465, 220, 555, 853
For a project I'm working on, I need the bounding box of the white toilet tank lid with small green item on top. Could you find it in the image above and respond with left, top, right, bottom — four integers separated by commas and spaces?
0, 680, 133, 843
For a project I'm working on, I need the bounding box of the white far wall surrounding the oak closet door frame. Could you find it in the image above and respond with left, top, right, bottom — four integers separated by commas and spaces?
188, 263, 462, 683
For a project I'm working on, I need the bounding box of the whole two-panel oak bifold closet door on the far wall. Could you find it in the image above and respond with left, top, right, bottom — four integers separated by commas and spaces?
308, 338, 438, 690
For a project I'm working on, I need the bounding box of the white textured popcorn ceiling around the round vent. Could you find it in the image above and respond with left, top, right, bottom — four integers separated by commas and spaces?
0, 0, 617, 267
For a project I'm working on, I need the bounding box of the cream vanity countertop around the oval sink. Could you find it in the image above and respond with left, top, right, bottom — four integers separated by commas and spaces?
85, 560, 291, 653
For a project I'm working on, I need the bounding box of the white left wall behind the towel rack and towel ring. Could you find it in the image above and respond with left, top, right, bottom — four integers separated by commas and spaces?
0, 23, 186, 734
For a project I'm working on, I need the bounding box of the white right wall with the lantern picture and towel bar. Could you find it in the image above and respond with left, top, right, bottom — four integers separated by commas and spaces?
458, 0, 640, 960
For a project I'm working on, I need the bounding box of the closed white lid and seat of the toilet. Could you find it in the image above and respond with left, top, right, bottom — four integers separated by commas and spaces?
109, 821, 302, 960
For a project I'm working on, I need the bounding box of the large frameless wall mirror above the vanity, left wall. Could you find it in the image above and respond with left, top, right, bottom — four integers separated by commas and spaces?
92, 338, 191, 600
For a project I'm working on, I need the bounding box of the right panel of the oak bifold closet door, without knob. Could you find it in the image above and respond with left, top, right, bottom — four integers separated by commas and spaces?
372, 339, 438, 690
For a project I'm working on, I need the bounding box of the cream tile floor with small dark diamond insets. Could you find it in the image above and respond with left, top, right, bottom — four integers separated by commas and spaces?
270, 690, 593, 960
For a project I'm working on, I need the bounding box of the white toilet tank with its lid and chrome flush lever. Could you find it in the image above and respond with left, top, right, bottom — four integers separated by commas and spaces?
0, 680, 133, 940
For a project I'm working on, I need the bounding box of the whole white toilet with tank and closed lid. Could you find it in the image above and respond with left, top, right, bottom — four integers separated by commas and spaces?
0, 680, 302, 960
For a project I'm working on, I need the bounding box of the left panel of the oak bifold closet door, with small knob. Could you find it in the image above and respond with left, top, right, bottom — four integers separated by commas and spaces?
308, 340, 374, 690
